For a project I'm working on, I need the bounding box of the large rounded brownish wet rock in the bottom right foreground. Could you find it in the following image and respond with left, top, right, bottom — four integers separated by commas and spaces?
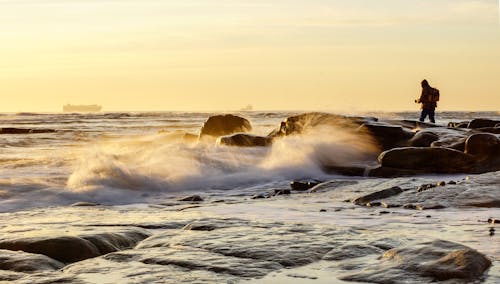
341, 240, 491, 283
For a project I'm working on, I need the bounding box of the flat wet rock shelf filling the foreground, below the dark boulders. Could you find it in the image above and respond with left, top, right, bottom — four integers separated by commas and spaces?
0, 169, 500, 283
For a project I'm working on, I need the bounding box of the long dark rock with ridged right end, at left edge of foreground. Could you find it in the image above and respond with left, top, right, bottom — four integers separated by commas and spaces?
0, 229, 149, 263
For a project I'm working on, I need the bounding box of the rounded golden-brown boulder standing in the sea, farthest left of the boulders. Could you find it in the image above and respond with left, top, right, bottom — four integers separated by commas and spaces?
200, 114, 252, 137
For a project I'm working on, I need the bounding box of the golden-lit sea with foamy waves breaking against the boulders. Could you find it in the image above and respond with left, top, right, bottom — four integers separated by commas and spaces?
0, 112, 500, 212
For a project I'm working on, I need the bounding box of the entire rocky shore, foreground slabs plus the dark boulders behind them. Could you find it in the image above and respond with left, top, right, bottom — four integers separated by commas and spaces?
0, 113, 500, 284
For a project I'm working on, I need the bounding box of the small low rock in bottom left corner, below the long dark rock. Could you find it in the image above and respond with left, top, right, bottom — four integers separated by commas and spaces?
0, 250, 64, 273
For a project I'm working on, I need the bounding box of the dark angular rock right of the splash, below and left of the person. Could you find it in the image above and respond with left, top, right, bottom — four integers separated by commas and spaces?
358, 122, 414, 150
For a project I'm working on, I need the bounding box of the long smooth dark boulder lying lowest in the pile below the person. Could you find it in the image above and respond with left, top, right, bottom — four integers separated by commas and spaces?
378, 147, 475, 173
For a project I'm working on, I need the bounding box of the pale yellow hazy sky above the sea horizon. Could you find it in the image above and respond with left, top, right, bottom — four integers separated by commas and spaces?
0, 0, 500, 112
